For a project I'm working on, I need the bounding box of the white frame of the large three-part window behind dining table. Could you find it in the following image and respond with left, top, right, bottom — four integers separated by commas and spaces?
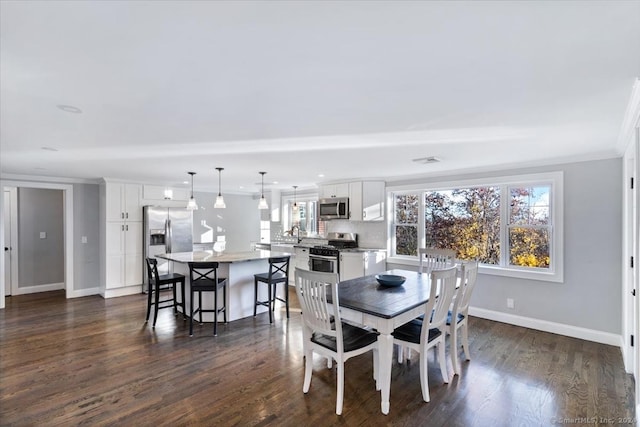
387, 171, 564, 283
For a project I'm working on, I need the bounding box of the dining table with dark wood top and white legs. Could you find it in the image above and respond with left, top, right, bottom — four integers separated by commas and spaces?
327, 269, 431, 415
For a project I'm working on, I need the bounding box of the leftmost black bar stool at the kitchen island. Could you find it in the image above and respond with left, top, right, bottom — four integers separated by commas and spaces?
144, 258, 187, 328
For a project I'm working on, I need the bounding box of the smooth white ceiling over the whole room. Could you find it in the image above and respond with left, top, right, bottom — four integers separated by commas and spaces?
0, 1, 640, 192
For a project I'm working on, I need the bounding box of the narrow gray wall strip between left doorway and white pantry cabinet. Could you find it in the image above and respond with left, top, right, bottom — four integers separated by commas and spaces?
73, 184, 100, 290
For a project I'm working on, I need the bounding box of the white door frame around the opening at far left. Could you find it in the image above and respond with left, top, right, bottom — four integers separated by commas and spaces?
0, 179, 74, 309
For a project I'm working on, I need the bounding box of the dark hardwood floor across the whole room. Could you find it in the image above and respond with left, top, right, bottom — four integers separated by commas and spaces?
0, 292, 635, 426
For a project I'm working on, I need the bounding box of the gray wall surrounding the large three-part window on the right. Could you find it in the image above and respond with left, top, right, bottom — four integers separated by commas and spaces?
388, 159, 622, 334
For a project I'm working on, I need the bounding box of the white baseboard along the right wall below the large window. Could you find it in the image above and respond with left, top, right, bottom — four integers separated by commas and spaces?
469, 307, 622, 348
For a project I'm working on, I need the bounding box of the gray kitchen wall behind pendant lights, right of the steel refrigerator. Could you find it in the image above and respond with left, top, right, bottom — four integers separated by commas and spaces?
193, 192, 261, 252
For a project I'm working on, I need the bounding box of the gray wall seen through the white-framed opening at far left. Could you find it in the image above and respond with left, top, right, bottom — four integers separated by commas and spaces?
18, 188, 64, 288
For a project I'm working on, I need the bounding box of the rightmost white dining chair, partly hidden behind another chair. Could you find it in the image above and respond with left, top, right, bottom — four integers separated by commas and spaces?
446, 261, 478, 375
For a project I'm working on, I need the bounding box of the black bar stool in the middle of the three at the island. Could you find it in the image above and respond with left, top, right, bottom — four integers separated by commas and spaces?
189, 262, 227, 337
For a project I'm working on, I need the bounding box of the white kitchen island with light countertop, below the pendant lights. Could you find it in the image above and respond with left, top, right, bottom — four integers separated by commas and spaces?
156, 251, 292, 322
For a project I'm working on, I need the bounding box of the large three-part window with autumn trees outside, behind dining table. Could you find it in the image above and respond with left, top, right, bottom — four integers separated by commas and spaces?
390, 173, 562, 281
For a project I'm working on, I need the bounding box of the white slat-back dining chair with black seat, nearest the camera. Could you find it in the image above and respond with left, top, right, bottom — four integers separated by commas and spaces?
295, 268, 380, 415
